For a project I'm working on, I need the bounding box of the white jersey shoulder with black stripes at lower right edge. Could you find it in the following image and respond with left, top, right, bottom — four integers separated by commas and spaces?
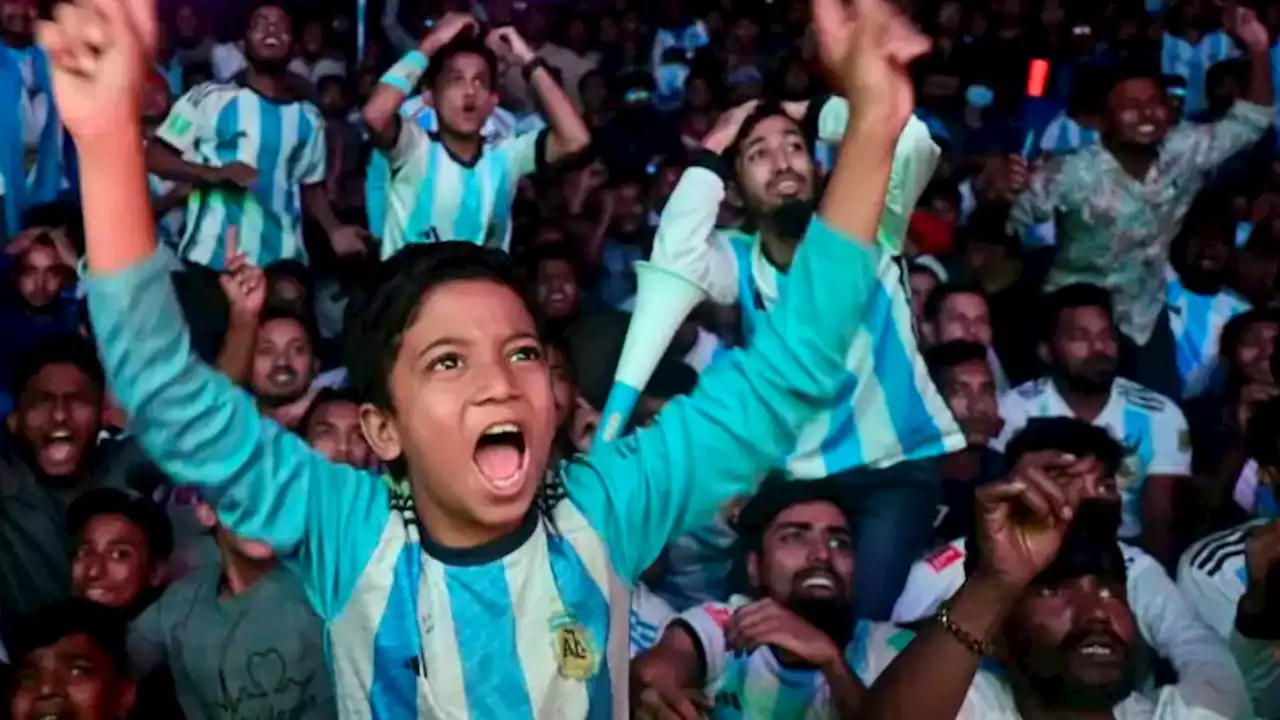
1178, 520, 1266, 638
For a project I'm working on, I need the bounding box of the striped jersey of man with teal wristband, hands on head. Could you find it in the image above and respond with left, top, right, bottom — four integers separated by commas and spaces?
381, 113, 547, 260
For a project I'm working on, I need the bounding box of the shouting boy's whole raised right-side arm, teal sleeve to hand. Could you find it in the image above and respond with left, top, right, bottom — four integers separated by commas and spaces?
567, 0, 929, 578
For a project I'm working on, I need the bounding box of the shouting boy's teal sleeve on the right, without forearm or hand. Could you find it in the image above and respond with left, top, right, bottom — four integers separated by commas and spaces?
564, 219, 879, 582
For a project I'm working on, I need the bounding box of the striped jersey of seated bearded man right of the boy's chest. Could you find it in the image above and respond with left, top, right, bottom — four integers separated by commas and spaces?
680, 596, 838, 720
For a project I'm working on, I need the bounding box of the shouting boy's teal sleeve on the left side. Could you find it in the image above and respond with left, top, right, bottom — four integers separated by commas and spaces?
87, 254, 390, 618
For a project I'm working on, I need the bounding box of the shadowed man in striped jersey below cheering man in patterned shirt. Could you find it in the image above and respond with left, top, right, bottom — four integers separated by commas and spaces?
1166, 192, 1249, 398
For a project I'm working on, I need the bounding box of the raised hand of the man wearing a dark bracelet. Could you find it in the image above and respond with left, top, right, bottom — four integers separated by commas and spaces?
972, 452, 1100, 593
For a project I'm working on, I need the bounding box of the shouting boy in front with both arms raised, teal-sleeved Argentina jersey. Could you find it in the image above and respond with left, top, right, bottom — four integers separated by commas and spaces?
41, 0, 929, 719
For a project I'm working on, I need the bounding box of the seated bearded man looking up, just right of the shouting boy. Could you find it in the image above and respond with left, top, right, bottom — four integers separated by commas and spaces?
632, 478, 863, 720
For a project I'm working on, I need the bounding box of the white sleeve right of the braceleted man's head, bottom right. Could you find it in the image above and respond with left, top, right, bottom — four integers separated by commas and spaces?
1128, 552, 1249, 717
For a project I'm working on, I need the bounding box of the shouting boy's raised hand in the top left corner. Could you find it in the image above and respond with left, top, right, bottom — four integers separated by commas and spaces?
36, 0, 157, 145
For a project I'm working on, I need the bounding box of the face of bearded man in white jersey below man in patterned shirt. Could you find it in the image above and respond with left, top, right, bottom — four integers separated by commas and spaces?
1052, 307, 1120, 392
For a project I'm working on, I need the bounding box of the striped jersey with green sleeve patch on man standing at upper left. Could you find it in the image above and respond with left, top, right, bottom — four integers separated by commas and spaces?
156, 82, 325, 270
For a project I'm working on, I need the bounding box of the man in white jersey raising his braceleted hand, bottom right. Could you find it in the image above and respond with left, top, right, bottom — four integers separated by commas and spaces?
852, 447, 1248, 720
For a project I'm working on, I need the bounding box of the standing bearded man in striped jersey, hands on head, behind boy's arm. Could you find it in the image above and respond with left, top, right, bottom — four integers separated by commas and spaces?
632, 89, 964, 620
